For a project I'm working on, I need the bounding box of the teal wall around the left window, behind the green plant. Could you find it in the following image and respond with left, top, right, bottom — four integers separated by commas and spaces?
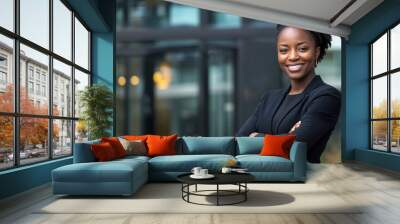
0, 0, 115, 199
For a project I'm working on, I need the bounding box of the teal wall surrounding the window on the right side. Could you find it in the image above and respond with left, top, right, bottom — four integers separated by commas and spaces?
342, 0, 400, 170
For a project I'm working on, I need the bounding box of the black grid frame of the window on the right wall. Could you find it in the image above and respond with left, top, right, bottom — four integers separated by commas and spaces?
368, 20, 400, 155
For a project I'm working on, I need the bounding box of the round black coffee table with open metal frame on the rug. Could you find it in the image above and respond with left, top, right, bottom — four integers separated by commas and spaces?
177, 173, 255, 206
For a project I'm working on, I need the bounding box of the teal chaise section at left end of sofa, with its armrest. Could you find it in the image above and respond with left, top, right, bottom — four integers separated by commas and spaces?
52, 142, 149, 195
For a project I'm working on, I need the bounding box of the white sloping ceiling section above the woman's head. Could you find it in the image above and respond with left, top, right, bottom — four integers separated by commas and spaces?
166, 0, 383, 37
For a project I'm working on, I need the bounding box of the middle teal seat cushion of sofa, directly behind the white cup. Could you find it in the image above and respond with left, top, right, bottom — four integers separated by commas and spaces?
149, 154, 235, 172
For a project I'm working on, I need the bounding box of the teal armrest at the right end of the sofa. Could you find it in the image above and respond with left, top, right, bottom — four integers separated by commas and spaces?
290, 141, 307, 181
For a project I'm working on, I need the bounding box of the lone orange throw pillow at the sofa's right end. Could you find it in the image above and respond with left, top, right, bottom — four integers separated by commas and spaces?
260, 135, 296, 159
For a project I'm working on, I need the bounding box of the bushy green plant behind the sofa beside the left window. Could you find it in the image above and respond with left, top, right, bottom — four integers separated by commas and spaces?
79, 84, 113, 140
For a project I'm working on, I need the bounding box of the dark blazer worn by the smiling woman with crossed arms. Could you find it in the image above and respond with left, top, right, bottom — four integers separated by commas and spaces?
236, 75, 340, 163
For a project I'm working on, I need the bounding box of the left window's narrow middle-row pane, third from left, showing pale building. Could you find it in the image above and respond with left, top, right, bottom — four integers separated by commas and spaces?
53, 59, 72, 117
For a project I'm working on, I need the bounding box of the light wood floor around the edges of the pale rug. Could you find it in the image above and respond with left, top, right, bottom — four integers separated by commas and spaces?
0, 163, 400, 224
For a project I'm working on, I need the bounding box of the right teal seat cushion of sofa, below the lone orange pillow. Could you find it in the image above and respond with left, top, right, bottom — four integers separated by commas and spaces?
236, 155, 293, 172
